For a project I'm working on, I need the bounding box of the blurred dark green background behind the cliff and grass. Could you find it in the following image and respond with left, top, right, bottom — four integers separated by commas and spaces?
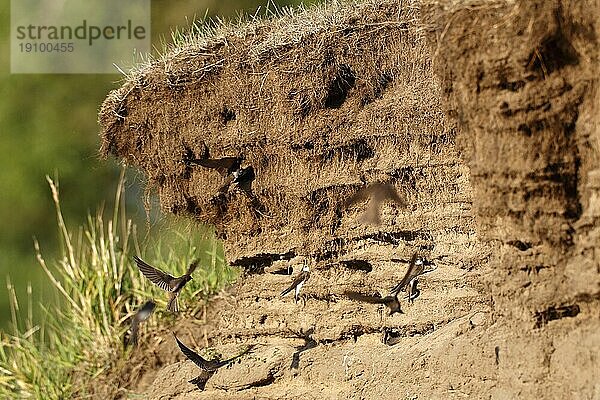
0, 0, 310, 329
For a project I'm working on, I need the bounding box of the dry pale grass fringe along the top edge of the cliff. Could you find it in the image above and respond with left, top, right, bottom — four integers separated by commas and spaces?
110, 0, 419, 87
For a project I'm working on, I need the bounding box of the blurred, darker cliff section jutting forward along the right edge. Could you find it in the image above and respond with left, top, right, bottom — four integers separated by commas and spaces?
424, 1, 600, 398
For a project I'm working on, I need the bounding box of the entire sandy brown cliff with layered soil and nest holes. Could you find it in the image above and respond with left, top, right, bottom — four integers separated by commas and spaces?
100, 1, 600, 399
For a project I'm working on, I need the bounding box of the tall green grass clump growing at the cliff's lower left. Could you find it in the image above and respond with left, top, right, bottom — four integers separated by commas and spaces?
0, 173, 237, 400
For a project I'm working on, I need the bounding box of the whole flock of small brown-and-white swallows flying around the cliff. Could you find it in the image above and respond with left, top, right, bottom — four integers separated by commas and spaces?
126, 154, 436, 390
